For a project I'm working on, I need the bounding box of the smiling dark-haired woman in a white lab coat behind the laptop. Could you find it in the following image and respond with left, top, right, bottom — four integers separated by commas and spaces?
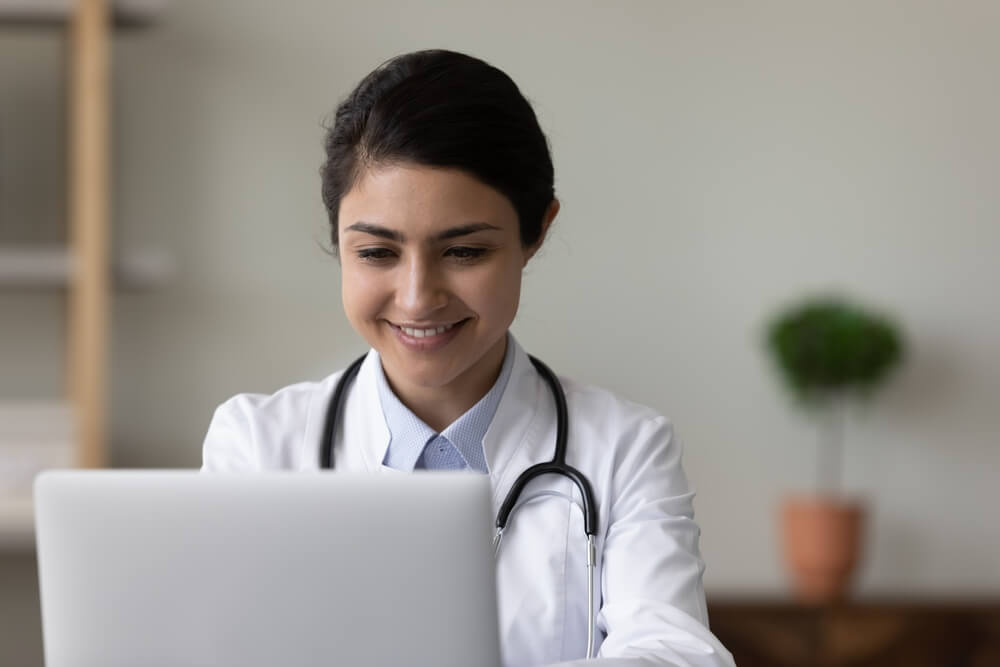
203, 51, 733, 667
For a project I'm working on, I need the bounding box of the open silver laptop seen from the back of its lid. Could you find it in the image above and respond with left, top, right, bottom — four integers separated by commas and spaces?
35, 471, 500, 667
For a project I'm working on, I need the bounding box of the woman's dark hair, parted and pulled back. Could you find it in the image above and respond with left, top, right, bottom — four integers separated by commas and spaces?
320, 50, 555, 248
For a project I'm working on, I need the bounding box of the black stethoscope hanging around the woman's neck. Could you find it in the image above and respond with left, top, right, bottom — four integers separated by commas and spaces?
319, 355, 597, 660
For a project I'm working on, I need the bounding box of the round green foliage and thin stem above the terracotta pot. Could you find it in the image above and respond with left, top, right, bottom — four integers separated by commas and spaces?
767, 298, 903, 492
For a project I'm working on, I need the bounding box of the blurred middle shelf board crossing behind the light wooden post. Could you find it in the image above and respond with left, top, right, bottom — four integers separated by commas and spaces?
0, 244, 175, 289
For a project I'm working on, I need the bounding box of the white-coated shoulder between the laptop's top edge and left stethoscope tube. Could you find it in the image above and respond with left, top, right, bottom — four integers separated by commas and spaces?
202, 371, 343, 471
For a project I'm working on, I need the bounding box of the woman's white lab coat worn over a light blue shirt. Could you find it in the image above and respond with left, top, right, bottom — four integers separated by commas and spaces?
203, 337, 734, 667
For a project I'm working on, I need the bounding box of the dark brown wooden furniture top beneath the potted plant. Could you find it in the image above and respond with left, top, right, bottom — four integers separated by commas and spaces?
708, 598, 1000, 667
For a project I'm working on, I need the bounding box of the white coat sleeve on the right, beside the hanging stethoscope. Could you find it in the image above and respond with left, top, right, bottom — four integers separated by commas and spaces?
560, 417, 735, 667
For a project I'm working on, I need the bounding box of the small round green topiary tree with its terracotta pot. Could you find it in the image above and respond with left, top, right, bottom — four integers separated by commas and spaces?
766, 298, 903, 601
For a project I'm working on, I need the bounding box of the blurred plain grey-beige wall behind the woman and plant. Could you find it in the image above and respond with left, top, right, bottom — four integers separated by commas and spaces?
0, 0, 1000, 665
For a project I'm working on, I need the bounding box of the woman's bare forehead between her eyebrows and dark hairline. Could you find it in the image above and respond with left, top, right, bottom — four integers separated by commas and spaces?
338, 164, 517, 232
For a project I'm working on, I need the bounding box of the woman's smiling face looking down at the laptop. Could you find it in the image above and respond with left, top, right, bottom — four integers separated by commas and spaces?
338, 165, 558, 402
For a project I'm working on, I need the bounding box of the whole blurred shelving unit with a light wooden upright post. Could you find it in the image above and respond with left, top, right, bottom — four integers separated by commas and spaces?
0, 0, 160, 486
